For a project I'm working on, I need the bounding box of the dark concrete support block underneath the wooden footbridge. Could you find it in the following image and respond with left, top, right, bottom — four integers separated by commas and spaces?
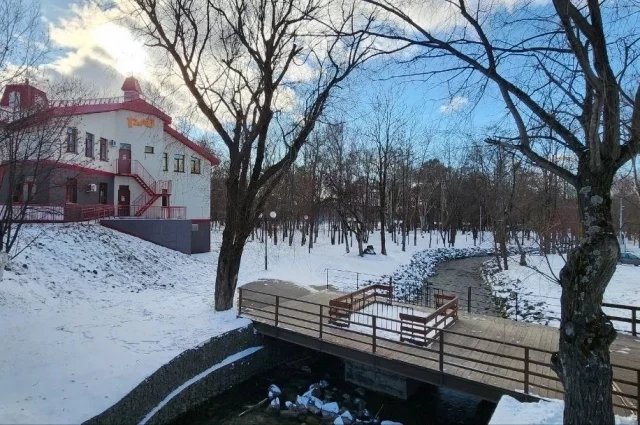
344, 359, 422, 400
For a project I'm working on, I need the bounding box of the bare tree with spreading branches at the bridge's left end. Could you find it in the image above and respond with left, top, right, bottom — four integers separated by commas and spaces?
135, 0, 372, 310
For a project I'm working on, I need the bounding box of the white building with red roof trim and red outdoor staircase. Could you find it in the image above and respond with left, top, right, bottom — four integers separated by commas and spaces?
0, 77, 220, 252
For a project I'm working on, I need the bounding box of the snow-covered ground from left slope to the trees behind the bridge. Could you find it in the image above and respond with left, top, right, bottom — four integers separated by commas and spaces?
0, 224, 490, 423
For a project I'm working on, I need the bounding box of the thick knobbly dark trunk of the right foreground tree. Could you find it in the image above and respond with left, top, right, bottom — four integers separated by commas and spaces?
552, 170, 620, 425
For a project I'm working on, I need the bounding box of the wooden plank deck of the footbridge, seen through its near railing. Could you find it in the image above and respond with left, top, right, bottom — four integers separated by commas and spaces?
239, 289, 640, 415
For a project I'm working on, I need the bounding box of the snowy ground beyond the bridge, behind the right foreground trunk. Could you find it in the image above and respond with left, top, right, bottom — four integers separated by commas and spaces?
491, 250, 640, 331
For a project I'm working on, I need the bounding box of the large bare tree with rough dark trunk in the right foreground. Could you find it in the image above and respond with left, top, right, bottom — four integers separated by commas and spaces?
364, 0, 640, 424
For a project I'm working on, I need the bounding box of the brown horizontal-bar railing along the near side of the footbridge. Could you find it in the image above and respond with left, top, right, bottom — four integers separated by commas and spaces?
238, 288, 640, 415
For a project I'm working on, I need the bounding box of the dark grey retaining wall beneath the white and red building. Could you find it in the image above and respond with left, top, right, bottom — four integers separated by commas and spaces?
100, 218, 211, 254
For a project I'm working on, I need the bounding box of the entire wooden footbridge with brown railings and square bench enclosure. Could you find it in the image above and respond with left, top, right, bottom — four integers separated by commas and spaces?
238, 284, 640, 416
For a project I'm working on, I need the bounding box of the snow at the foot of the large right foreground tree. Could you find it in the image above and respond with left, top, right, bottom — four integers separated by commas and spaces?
489, 396, 638, 425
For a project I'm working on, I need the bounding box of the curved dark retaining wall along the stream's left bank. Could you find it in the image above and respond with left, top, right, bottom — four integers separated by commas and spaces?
85, 326, 310, 425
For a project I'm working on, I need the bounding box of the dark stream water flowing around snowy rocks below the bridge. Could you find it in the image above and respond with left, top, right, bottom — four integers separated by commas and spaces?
175, 356, 495, 425
